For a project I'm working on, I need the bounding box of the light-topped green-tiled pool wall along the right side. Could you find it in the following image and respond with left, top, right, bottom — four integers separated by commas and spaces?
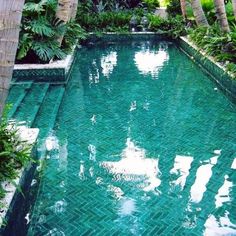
178, 37, 236, 101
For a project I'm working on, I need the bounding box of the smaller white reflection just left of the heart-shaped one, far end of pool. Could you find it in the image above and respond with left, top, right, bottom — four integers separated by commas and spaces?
101, 52, 117, 77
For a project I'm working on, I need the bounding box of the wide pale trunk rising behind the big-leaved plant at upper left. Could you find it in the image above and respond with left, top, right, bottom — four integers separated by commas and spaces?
56, 0, 73, 45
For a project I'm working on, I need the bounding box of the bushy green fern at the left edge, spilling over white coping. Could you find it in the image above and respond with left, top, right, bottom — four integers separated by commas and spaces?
0, 108, 32, 198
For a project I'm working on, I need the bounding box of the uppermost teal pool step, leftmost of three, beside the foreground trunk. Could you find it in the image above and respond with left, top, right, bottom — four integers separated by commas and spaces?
7, 81, 33, 120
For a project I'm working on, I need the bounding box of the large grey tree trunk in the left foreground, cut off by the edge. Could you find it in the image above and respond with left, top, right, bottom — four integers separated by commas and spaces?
0, 0, 25, 117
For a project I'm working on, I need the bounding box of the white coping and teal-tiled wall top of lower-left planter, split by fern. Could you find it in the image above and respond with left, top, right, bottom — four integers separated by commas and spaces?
0, 126, 39, 230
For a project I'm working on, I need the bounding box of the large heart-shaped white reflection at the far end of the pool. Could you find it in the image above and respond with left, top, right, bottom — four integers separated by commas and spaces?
134, 49, 169, 77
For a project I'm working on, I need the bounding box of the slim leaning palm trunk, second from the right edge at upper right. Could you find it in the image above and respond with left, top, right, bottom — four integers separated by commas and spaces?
214, 0, 230, 32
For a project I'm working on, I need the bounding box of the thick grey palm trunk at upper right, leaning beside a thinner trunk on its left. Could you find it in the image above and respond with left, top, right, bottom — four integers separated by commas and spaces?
191, 0, 209, 27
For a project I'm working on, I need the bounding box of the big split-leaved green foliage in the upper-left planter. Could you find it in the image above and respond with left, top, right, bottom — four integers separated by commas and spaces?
17, 0, 85, 63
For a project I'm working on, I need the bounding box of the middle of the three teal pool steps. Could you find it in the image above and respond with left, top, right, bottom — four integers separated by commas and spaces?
13, 83, 49, 127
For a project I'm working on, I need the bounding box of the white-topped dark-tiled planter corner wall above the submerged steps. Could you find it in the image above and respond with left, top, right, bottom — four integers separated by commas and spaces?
13, 47, 77, 84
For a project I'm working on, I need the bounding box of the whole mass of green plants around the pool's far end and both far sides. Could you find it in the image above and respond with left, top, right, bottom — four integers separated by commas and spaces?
17, 0, 236, 74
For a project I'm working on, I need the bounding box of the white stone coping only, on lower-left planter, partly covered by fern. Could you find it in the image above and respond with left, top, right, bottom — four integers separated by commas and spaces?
0, 125, 39, 228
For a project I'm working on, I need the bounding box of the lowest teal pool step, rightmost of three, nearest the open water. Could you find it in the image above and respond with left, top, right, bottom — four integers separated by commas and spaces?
32, 85, 65, 158
